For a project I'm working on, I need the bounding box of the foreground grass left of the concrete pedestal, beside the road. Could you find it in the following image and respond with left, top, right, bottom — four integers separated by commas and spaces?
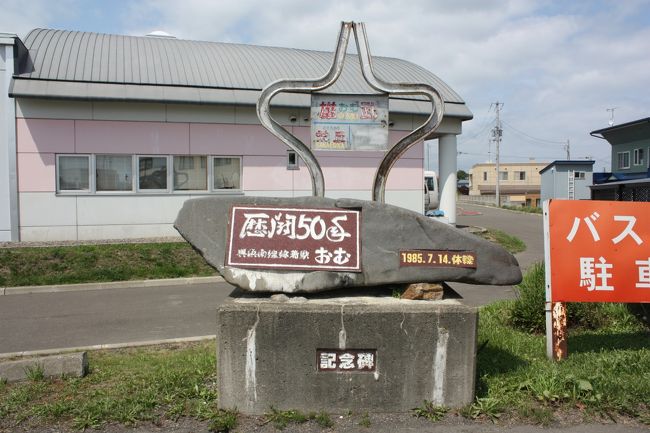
0, 342, 228, 431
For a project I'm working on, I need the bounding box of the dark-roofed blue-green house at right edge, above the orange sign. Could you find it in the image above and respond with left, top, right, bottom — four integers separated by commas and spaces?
590, 117, 650, 201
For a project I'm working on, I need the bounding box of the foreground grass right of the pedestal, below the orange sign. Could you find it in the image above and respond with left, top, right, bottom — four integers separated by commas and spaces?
476, 301, 650, 425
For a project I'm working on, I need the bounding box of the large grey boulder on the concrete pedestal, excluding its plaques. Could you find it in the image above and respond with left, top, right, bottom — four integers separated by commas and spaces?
175, 197, 521, 292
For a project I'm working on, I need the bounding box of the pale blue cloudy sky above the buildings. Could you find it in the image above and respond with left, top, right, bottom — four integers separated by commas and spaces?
0, 0, 650, 171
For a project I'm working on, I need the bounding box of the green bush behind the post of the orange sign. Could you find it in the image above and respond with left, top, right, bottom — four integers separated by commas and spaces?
510, 263, 606, 333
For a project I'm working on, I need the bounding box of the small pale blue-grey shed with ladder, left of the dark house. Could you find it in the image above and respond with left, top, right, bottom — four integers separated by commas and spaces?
539, 160, 595, 201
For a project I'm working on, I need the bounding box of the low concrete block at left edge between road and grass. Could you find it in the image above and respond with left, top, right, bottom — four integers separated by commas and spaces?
0, 352, 88, 382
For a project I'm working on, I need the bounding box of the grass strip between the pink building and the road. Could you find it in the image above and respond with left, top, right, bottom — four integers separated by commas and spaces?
0, 242, 215, 287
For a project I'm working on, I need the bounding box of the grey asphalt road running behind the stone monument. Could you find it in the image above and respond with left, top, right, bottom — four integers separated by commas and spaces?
0, 205, 543, 353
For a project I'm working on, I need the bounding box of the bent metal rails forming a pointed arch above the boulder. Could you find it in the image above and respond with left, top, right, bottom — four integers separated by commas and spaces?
256, 22, 444, 203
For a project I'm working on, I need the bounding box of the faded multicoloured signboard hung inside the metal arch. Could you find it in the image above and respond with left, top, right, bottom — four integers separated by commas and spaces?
311, 94, 388, 151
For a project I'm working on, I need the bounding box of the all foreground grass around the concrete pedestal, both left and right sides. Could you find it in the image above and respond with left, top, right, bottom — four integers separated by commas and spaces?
0, 302, 650, 431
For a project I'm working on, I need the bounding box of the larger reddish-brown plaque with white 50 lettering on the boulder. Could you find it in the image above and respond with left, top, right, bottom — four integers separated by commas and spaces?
226, 205, 361, 272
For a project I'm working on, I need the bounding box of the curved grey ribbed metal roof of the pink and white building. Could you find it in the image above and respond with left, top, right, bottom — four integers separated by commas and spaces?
10, 29, 472, 120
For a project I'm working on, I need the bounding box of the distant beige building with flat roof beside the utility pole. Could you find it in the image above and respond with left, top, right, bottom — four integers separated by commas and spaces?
469, 162, 548, 207
